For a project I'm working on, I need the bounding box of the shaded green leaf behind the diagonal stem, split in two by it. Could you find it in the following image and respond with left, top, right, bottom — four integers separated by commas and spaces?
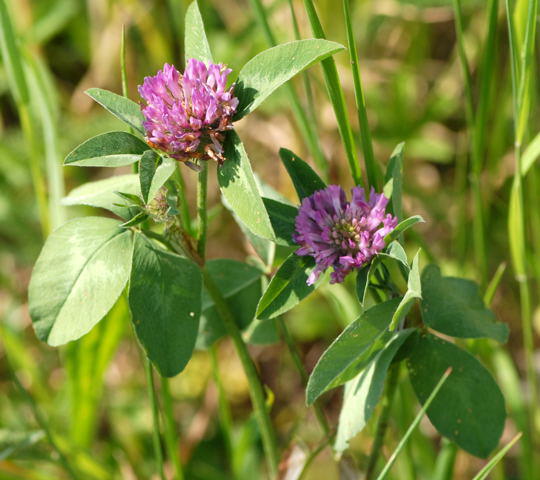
197, 258, 263, 349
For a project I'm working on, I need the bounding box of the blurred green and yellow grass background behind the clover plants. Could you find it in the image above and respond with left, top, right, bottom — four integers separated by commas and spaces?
0, 0, 540, 480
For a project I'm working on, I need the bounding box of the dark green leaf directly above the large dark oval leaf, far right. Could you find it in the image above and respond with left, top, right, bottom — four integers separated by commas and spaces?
422, 265, 508, 343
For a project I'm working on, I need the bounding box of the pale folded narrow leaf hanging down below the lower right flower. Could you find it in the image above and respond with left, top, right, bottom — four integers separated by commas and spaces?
334, 329, 413, 452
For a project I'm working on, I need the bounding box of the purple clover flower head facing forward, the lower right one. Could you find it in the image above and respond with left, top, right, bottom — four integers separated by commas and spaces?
293, 185, 398, 285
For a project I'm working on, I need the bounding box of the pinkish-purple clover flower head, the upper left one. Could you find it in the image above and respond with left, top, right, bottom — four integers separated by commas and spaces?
139, 58, 238, 167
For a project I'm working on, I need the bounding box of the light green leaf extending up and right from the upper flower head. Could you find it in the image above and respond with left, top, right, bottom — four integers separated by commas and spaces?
234, 38, 345, 120
